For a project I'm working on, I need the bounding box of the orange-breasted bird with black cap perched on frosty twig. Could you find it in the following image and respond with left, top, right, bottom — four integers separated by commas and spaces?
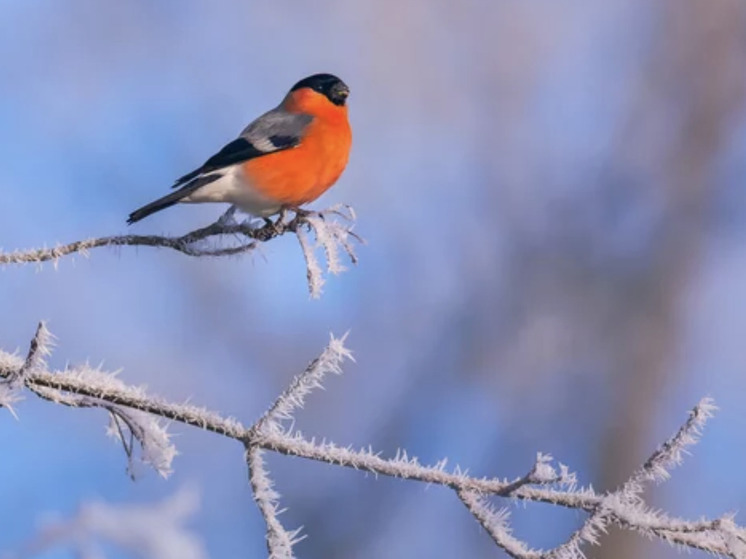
127, 74, 352, 225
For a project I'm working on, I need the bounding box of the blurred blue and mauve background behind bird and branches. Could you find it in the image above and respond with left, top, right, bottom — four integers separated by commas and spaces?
0, 0, 746, 559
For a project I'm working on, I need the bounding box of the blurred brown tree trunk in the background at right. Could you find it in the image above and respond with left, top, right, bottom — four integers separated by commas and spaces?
592, 0, 746, 559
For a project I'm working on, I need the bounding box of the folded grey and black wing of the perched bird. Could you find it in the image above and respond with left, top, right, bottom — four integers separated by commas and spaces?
172, 107, 313, 188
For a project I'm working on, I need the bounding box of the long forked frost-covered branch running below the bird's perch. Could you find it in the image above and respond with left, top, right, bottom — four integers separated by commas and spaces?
0, 324, 746, 559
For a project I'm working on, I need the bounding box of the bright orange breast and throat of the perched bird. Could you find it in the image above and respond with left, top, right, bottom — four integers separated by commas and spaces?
243, 110, 352, 206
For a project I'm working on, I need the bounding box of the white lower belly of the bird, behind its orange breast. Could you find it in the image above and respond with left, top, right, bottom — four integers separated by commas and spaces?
180, 165, 281, 217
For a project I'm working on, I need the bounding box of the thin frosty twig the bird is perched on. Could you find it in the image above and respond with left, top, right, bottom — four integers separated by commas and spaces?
0, 204, 362, 298
